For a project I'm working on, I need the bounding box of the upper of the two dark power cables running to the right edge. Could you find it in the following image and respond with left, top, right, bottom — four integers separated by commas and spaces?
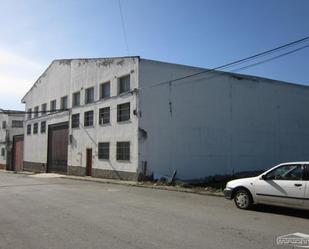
140, 36, 309, 89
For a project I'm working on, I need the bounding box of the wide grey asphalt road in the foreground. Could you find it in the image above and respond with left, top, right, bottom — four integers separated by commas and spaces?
0, 173, 309, 249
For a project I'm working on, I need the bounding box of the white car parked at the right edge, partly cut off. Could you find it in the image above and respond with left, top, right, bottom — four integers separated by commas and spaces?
223, 162, 309, 210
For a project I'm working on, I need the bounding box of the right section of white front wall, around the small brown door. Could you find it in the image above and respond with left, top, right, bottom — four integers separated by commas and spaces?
68, 57, 138, 172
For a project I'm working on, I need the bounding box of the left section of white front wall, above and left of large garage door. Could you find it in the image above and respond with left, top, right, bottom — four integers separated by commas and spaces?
23, 61, 71, 163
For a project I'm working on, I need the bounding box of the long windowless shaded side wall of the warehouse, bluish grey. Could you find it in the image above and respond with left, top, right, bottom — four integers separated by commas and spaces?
139, 60, 309, 179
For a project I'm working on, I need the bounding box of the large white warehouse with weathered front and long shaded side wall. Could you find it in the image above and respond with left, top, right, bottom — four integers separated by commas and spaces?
22, 56, 309, 180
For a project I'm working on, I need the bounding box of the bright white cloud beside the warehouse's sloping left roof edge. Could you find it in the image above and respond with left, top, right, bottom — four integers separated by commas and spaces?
0, 49, 44, 99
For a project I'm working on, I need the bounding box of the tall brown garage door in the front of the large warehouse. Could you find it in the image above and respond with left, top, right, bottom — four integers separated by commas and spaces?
47, 123, 69, 173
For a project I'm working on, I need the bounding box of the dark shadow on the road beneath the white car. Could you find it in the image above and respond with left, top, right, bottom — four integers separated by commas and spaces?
252, 204, 309, 219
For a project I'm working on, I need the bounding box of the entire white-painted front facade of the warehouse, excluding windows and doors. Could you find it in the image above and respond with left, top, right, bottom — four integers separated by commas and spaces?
24, 57, 138, 172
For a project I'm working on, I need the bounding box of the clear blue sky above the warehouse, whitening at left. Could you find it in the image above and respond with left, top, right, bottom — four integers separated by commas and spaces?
0, 0, 309, 110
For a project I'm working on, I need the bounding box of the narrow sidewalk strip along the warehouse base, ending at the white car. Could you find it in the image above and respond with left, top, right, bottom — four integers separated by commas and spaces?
0, 170, 224, 197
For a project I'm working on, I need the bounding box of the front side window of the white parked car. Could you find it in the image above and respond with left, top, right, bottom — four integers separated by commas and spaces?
266, 165, 303, 181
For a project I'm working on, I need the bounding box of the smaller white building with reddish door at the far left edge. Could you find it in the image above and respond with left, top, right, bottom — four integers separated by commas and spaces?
0, 109, 25, 171
